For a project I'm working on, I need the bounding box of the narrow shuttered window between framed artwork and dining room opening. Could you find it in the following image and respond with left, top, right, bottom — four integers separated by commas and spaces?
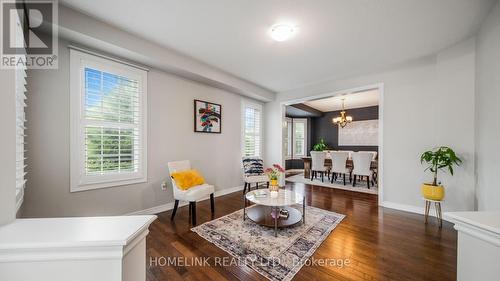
242, 101, 262, 157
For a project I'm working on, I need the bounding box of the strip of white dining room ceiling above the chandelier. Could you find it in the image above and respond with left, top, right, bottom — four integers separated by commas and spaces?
304, 90, 379, 112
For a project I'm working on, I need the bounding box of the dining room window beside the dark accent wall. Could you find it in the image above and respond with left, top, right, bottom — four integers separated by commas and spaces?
285, 118, 307, 158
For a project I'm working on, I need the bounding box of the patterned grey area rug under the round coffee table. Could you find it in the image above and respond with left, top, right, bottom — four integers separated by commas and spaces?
191, 206, 345, 280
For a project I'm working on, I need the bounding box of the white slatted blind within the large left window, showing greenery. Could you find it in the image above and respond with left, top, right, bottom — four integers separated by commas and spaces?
84, 67, 141, 175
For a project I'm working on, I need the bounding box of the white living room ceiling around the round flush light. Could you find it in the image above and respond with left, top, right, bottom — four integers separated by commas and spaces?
60, 0, 495, 92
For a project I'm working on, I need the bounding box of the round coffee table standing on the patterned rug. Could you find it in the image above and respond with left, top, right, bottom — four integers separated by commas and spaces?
243, 189, 306, 236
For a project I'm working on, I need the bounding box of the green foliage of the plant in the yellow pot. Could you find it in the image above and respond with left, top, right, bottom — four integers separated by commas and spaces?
420, 146, 462, 186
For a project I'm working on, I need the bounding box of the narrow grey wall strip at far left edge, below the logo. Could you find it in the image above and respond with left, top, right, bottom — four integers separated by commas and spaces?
0, 69, 16, 225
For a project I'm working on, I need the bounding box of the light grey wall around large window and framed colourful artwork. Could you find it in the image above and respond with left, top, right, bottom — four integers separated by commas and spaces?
23, 37, 256, 217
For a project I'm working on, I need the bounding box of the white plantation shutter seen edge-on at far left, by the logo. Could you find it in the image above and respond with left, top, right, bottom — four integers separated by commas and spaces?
15, 13, 27, 209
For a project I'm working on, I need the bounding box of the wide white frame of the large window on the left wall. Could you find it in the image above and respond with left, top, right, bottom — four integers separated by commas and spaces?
70, 48, 148, 192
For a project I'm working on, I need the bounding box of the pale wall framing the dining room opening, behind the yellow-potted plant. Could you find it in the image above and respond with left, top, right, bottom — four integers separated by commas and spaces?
265, 38, 475, 211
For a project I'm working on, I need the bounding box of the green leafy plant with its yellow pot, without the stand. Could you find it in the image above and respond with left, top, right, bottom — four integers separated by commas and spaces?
420, 146, 462, 201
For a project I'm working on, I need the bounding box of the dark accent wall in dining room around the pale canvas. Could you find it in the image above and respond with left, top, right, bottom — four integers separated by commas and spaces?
309, 106, 378, 151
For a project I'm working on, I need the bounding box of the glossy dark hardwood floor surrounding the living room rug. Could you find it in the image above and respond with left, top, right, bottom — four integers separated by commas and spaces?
147, 183, 457, 281
